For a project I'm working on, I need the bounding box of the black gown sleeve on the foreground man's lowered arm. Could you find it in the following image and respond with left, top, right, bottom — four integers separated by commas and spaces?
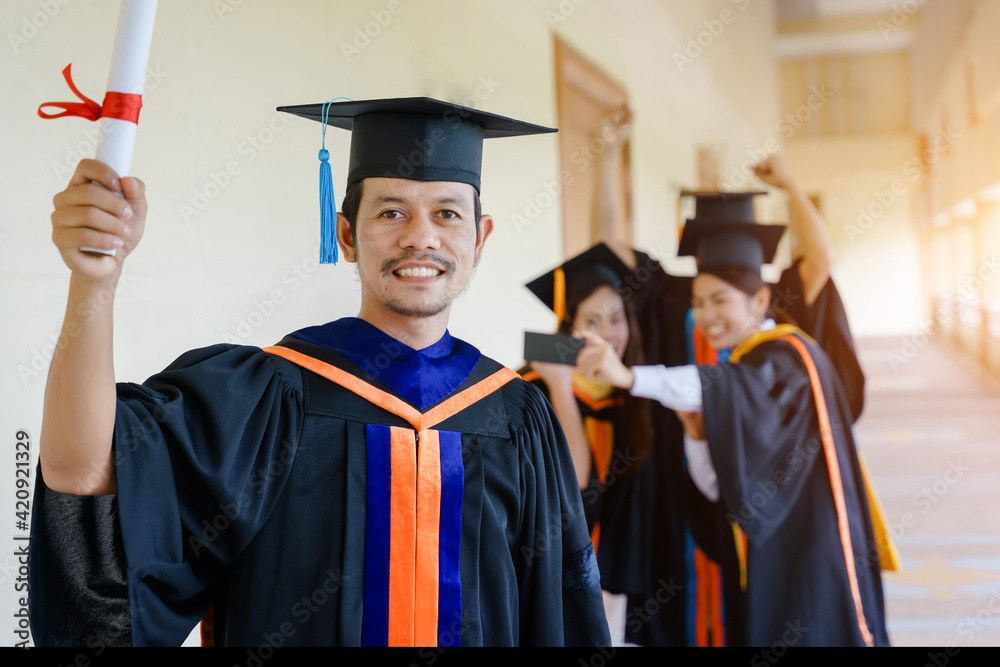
510, 383, 611, 646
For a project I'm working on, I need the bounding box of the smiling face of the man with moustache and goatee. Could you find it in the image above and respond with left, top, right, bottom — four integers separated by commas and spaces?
337, 178, 493, 318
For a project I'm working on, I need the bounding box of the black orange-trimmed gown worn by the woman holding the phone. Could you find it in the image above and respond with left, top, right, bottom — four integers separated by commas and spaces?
698, 337, 889, 646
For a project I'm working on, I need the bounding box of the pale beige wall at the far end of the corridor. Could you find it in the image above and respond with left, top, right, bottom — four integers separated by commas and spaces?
779, 43, 923, 336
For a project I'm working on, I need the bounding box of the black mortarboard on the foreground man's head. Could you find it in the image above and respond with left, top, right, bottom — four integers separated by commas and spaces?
278, 97, 556, 191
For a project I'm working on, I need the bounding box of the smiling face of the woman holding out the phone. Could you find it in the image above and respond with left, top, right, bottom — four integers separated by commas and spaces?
691, 273, 770, 350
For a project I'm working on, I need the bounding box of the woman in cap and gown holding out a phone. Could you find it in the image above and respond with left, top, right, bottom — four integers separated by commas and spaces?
577, 215, 888, 646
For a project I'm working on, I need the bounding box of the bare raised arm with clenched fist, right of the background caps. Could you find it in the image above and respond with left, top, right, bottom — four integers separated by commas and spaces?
754, 155, 837, 305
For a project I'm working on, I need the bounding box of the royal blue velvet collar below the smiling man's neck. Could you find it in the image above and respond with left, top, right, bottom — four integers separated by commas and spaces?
289, 317, 481, 410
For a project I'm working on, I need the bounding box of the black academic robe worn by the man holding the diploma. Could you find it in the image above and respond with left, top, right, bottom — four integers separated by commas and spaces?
30, 338, 610, 647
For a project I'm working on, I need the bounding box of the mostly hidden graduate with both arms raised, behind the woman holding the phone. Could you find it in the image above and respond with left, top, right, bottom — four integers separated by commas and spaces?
592, 110, 876, 646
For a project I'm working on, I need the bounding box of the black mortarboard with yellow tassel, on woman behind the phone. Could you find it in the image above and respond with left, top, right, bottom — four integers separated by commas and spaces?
526, 243, 632, 324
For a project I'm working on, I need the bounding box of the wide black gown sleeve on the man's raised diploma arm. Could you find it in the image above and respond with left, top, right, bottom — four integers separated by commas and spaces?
31, 345, 303, 646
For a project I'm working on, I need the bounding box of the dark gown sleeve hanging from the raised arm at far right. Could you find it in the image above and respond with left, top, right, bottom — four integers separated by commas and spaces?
771, 259, 865, 421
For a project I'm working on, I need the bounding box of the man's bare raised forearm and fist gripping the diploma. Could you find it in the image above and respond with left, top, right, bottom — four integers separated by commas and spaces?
39, 160, 146, 495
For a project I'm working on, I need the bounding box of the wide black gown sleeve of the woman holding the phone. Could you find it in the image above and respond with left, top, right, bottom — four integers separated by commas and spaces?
698, 342, 828, 543
